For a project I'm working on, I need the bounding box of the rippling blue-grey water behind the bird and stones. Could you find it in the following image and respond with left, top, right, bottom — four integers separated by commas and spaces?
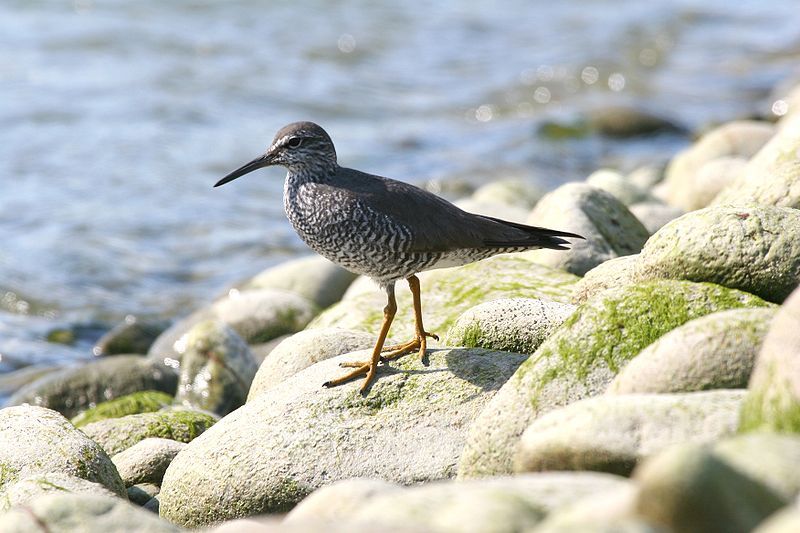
0, 0, 800, 366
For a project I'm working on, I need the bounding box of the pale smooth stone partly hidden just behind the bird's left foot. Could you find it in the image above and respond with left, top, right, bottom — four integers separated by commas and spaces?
247, 328, 375, 401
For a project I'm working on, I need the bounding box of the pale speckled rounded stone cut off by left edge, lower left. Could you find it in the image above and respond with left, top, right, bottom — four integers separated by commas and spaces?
0, 406, 125, 496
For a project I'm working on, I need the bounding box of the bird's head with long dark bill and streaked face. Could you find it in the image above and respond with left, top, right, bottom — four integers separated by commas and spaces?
214, 122, 336, 187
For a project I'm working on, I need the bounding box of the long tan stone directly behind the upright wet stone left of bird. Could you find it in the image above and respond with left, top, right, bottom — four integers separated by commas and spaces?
147, 289, 319, 362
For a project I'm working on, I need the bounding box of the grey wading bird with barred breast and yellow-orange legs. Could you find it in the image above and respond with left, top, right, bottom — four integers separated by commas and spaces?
214, 122, 583, 393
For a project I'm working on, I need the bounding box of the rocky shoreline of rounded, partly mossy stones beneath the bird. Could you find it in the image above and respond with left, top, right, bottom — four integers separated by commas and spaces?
0, 80, 800, 533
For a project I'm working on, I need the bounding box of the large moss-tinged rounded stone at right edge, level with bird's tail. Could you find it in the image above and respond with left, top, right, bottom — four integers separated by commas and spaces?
634, 206, 800, 303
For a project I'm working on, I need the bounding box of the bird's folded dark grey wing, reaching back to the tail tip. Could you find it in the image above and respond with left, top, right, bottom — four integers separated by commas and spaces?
336, 168, 582, 252
